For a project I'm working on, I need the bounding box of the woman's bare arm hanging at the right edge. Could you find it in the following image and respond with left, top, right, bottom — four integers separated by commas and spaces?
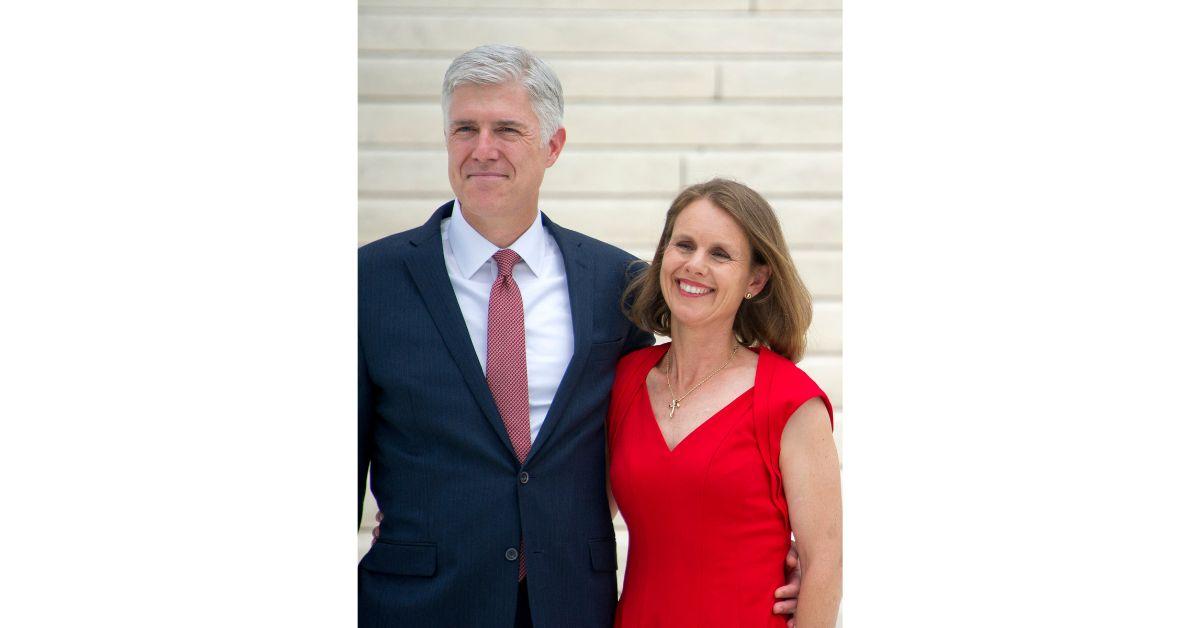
779, 397, 841, 628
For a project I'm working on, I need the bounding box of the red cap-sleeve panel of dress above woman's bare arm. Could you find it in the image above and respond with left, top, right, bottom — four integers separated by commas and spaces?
754, 347, 833, 528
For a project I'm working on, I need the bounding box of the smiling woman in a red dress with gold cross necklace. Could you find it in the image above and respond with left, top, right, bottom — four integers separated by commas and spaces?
608, 179, 841, 627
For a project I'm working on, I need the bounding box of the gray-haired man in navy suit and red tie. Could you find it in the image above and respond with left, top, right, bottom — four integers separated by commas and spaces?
359, 46, 796, 628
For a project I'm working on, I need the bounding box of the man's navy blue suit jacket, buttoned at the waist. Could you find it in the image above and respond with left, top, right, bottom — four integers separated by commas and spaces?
359, 203, 653, 628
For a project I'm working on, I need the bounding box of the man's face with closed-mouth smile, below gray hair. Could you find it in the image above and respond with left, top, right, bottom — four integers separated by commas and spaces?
446, 83, 566, 219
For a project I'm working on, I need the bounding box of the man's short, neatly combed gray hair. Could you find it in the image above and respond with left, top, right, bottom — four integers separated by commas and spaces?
442, 43, 563, 145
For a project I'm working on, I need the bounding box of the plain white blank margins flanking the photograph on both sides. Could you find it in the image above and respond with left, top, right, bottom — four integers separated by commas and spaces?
0, 2, 1200, 627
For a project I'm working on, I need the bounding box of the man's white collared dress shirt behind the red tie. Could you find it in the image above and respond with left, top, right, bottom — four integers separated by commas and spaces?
442, 199, 575, 442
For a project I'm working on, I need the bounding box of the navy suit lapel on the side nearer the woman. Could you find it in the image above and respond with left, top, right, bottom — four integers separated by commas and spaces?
527, 214, 595, 463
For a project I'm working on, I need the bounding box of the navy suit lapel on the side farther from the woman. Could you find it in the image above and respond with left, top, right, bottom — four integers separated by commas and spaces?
406, 202, 516, 457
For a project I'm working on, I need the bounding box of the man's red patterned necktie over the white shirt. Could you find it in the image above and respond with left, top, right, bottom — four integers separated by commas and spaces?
487, 249, 532, 580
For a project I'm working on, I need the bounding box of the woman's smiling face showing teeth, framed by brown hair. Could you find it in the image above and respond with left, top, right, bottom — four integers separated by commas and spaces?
659, 198, 769, 330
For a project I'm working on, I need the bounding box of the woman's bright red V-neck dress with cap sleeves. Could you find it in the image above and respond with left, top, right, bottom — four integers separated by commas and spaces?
608, 345, 833, 628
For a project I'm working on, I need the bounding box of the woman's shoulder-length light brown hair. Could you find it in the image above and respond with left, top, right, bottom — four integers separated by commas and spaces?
622, 179, 812, 361
